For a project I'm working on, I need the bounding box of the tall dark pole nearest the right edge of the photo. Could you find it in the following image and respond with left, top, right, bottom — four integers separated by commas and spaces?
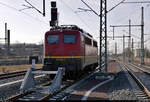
141, 7, 144, 65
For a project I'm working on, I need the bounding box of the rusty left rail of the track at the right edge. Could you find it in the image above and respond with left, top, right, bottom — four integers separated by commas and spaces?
122, 63, 150, 99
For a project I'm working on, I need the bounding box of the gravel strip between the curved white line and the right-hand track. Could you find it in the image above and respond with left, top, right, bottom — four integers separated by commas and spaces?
108, 64, 138, 100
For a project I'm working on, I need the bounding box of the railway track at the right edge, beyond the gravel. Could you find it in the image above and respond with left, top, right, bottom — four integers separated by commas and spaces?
119, 63, 150, 101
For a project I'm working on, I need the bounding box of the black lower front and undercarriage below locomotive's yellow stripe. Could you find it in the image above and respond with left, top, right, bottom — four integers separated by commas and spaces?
43, 58, 82, 79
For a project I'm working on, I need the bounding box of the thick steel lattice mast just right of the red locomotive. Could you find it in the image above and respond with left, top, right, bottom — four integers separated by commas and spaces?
99, 0, 107, 72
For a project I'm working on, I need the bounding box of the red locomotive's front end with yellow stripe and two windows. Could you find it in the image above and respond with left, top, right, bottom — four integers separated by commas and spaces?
43, 30, 83, 78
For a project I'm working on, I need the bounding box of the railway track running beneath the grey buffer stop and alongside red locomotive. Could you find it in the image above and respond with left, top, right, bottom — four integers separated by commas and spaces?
7, 67, 96, 101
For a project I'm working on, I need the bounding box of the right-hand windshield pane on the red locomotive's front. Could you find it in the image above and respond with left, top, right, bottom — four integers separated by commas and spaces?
64, 34, 76, 44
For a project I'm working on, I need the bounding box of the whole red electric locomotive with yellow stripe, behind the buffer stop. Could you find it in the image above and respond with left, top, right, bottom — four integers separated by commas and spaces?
43, 25, 98, 78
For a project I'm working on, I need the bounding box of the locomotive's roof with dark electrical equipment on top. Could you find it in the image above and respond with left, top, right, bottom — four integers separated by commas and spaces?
50, 25, 94, 40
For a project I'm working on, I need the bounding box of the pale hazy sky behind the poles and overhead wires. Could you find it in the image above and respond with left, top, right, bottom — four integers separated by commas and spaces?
0, 0, 150, 52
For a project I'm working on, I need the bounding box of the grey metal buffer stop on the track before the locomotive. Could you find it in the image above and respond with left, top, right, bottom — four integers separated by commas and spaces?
19, 60, 64, 100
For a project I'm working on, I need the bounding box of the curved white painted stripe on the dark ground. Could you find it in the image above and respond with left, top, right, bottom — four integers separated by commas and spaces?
81, 77, 114, 100
